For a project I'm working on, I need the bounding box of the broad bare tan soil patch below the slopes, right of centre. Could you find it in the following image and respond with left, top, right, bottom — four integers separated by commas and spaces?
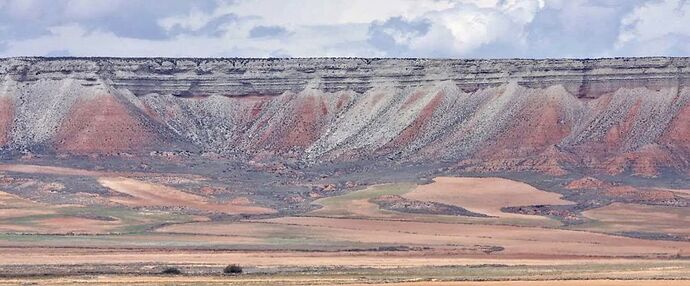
404, 177, 572, 220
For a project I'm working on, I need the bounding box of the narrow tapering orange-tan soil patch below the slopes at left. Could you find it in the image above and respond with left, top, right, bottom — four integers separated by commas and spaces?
98, 177, 275, 214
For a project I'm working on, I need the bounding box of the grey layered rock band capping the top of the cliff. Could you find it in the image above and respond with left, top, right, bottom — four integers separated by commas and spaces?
0, 57, 690, 97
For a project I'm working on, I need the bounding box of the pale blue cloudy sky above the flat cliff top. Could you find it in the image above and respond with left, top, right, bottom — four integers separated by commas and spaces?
0, 0, 690, 58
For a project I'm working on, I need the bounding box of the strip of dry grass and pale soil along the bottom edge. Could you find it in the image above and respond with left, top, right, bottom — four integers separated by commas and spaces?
0, 261, 690, 286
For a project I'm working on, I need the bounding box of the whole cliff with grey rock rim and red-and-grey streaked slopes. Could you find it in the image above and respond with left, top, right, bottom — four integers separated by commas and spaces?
0, 58, 690, 175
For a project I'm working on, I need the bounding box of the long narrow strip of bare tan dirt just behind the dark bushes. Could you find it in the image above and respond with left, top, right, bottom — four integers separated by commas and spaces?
1, 247, 690, 269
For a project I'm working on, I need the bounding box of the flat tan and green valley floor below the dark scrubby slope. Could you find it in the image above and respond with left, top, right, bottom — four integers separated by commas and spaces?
0, 160, 690, 285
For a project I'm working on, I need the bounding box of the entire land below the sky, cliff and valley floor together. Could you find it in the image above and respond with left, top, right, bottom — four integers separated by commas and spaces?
0, 58, 690, 286
